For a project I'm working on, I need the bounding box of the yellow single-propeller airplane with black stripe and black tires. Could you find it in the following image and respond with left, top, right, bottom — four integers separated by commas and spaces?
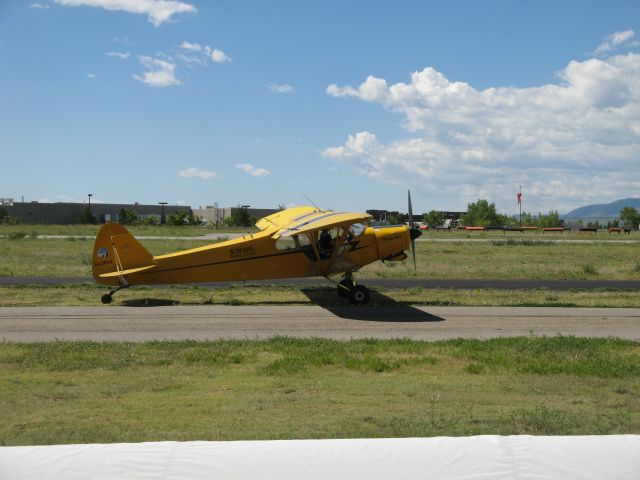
92, 193, 421, 305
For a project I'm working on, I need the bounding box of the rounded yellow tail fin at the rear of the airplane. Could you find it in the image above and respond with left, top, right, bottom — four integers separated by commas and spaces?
91, 222, 154, 284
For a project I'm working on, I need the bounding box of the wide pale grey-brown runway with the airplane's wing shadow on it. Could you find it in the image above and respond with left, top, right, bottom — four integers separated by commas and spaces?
0, 306, 640, 342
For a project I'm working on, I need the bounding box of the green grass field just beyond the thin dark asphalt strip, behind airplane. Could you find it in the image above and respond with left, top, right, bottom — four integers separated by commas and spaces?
0, 234, 640, 280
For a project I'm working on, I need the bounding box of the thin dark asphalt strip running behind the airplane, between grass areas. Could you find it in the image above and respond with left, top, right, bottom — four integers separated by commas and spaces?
0, 277, 640, 290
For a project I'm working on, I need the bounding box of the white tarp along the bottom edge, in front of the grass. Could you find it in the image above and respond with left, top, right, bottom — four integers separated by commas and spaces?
0, 435, 640, 480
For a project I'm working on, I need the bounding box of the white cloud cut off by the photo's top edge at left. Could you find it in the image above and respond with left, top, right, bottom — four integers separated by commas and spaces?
55, 0, 196, 27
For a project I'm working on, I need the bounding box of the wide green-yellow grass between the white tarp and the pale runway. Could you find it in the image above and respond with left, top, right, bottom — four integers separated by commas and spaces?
0, 337, 640, 445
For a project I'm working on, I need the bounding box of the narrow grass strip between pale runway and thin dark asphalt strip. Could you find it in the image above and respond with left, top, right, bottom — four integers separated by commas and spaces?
0, 284, 640, 308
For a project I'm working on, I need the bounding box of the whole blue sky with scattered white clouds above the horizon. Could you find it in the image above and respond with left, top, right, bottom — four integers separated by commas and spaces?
0, 0, 640, 212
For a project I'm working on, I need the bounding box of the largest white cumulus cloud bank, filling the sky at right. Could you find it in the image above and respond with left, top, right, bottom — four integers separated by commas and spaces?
322, 50, 640, 211
